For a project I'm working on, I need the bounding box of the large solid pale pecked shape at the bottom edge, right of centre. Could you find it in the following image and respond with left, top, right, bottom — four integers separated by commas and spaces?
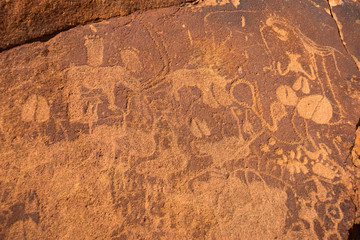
166, 171, 287, 239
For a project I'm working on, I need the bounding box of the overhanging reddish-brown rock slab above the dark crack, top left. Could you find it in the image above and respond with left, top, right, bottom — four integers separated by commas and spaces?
0, 0, 192, 50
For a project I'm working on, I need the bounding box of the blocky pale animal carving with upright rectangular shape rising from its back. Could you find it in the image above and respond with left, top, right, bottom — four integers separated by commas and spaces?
64, 36, 142, 130
